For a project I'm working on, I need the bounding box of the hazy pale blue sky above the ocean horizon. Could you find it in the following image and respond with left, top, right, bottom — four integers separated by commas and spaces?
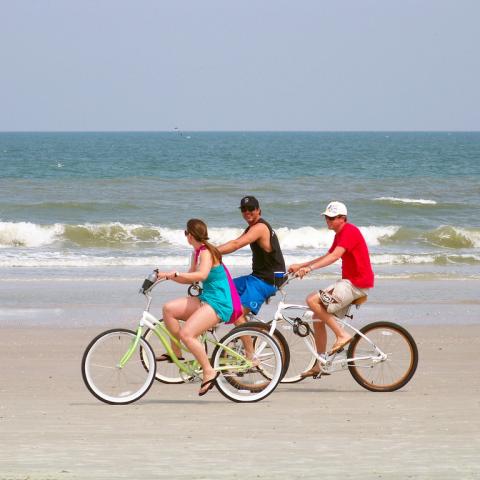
0, 0, 480, 131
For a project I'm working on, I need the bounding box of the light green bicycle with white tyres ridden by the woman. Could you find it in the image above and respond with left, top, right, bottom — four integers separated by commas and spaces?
82, 272, 283, 405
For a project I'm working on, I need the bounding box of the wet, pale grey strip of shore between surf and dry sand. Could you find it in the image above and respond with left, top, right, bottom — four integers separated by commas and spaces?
0, 269, 480, 329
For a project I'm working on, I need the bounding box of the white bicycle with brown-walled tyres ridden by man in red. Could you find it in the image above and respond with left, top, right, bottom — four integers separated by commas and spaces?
252, 275, 418, 392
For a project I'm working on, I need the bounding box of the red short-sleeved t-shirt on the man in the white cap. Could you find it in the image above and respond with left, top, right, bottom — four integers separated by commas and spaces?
328, 223, 373, 288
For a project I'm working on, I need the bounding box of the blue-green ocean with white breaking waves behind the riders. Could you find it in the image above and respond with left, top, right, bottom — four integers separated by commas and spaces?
0, 131, 480, 279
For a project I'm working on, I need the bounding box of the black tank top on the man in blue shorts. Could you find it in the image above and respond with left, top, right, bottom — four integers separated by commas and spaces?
245, 218, 285, 285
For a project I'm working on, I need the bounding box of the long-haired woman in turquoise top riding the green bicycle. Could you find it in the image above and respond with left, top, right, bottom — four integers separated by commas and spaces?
157, 218, 233, 395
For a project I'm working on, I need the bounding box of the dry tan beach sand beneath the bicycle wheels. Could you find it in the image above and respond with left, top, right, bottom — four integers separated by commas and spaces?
0, 276, 480, 480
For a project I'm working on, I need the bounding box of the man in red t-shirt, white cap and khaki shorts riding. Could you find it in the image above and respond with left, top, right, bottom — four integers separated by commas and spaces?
288, 202, 374, 377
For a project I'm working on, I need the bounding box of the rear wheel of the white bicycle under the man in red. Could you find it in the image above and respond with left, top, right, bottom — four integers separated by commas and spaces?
347, 322, 418, 392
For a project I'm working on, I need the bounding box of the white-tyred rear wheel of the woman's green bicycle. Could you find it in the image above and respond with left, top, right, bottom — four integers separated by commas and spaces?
212, 327, 283, 402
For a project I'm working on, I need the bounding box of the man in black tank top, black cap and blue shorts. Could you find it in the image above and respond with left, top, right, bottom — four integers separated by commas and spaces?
218, 196, 285, 324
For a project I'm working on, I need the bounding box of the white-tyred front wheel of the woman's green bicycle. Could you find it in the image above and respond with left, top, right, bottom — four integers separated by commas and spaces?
82, 328, 156, 404
